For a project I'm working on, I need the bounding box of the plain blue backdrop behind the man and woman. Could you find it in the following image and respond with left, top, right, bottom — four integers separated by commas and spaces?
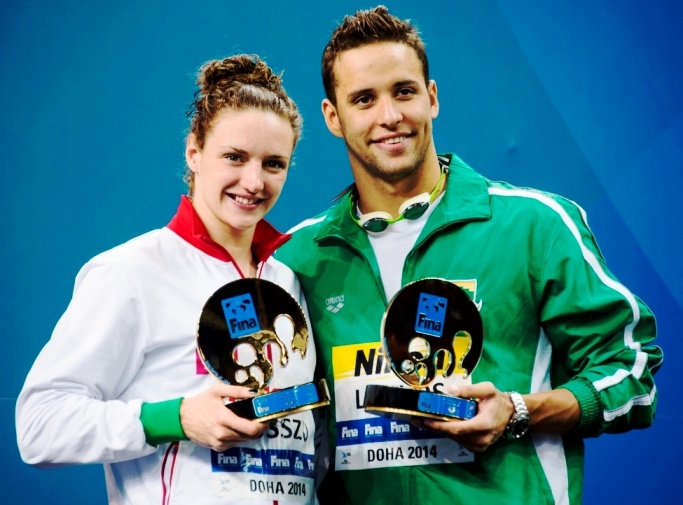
0, 0, 683, 504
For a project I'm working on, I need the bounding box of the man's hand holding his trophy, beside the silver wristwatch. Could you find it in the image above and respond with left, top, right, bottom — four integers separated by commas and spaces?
415, 382, 514, 452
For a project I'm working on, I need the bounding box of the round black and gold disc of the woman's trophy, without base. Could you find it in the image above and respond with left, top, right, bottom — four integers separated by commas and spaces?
197, 278, 308, 390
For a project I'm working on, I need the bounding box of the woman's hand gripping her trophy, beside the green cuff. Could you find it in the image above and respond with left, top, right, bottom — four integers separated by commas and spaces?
180, 383, 269, 451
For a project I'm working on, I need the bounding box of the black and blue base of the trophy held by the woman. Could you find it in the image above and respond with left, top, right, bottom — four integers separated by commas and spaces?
226, 379, 330, 422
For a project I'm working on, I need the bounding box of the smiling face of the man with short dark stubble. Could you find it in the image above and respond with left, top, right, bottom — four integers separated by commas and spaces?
322, 42, 439, 183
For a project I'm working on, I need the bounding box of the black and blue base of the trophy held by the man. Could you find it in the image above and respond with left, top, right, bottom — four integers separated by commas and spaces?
363, 385, 477, 421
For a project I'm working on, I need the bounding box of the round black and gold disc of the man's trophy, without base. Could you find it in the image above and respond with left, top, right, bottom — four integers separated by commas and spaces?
381, 278, 484, 388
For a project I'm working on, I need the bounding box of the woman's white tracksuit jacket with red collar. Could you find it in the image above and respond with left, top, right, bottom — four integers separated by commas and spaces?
16, 197, 315, 505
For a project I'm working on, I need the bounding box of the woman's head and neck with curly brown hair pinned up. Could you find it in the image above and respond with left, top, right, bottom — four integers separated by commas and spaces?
185, 55, 302, 277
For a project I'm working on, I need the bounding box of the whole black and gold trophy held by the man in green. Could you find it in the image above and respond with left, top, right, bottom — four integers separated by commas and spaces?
363, 279, 484, 421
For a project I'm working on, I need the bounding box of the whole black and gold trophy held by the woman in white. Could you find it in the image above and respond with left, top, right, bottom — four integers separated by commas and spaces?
197, 278, 330, 421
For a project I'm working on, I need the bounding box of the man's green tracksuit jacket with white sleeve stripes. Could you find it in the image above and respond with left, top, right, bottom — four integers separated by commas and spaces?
276, 155, 662, 505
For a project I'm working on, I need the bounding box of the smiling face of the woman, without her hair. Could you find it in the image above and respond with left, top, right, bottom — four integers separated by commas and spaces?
185, 109, 294, 243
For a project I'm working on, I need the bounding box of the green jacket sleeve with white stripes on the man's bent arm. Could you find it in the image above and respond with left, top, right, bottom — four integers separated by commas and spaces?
541, 199, 663, 436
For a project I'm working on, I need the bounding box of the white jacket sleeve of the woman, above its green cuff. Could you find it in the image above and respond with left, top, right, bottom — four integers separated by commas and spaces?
16, 261, 155, 467
